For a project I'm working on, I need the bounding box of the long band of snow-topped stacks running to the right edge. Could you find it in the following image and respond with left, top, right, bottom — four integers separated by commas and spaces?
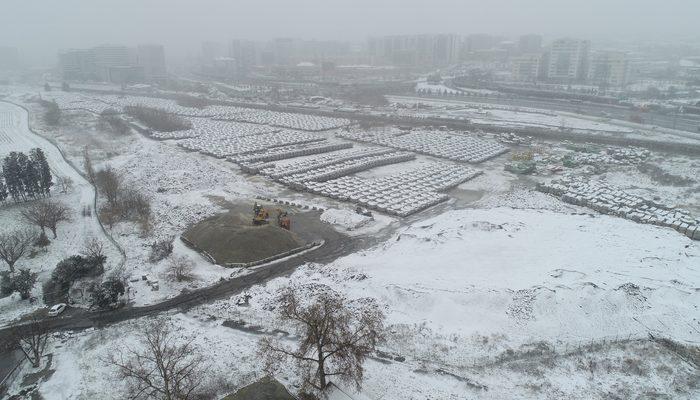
537, 177, 700, 240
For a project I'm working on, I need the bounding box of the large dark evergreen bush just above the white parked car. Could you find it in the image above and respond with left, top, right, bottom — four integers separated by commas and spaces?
44, 255, 107, 304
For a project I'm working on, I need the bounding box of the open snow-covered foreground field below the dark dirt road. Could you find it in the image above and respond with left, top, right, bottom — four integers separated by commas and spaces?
23, 198, 700, 400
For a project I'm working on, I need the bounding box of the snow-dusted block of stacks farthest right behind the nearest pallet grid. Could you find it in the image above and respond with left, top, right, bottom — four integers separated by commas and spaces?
338, 131, 508, 163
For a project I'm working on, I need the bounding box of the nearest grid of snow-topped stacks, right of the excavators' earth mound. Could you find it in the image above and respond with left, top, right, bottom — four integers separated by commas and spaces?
302, 163, 481, 217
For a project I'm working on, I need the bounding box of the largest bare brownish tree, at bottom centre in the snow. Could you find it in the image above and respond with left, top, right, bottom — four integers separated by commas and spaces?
259, 285, 384, 391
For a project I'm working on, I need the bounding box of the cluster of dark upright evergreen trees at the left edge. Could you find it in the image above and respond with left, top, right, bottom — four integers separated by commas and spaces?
0, 147, 53, 202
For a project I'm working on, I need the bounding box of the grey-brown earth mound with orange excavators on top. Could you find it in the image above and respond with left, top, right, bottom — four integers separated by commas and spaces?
182, 212, 305, 265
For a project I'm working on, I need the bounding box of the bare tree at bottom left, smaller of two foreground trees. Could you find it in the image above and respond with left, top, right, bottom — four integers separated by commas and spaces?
107, 319, 206, 400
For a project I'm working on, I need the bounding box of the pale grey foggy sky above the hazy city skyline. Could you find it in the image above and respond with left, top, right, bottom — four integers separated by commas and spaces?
0, 0, 700, 65
